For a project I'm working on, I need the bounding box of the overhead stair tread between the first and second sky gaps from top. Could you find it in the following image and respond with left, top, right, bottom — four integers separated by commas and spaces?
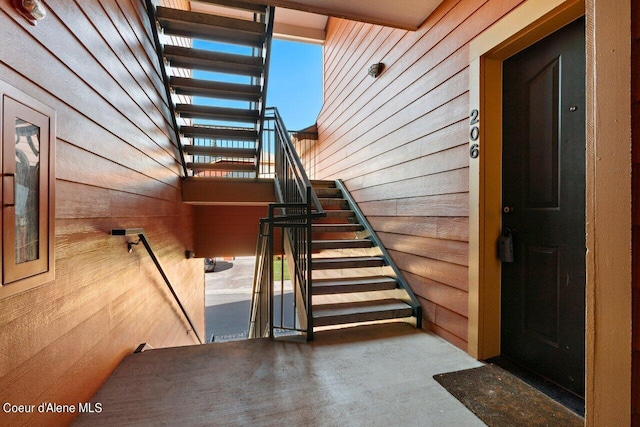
163, 45, 263, 77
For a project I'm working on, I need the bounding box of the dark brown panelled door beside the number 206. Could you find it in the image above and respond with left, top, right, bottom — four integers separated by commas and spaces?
501, 19, 586, 396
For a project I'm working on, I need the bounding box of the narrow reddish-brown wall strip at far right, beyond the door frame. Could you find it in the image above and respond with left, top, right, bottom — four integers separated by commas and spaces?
631, 0, 640, 426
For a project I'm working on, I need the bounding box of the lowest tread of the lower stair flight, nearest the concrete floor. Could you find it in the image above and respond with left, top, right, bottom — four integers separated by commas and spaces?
313, 299, 413, 326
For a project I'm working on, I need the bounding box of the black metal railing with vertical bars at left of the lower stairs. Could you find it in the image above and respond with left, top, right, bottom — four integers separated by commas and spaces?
249, 108, 325, 340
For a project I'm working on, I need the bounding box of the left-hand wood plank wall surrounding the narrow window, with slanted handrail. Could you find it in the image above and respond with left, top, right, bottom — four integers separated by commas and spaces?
0, 0, 204, 425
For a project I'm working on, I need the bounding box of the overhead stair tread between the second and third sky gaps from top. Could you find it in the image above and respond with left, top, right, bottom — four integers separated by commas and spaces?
169, 76, 262, 101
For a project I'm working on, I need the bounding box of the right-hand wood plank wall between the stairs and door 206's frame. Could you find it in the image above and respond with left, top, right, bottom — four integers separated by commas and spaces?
316, 0, 522, 349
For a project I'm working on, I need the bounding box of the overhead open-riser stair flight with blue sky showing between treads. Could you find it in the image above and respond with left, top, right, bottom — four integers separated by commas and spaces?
147, 0, 273, 177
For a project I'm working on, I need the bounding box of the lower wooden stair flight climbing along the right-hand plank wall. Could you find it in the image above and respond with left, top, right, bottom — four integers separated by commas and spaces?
312, 181, 421, 330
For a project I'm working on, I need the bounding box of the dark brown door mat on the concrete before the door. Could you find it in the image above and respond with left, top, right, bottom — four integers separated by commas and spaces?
433, 365, 584, 427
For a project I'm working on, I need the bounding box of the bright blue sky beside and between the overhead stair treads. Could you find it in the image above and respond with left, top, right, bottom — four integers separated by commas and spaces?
189, 39, 322, 131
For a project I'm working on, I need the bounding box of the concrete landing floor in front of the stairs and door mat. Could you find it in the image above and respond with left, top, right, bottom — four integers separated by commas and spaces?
76, 323, 484, 426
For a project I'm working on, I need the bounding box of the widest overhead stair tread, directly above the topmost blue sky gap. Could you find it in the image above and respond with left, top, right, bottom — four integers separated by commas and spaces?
156, 6, 265, 47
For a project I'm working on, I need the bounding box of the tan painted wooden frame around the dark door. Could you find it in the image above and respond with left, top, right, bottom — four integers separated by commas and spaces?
468, 0, 632, 425
